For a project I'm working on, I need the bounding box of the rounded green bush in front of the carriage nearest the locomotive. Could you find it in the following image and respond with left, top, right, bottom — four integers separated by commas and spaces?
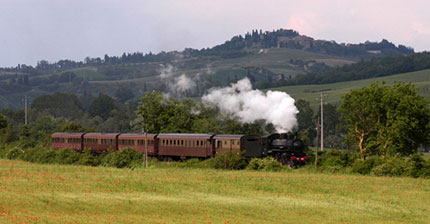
214, 151, 247, 170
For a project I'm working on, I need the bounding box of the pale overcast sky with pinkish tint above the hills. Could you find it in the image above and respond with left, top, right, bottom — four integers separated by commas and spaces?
0, 0, 430, 67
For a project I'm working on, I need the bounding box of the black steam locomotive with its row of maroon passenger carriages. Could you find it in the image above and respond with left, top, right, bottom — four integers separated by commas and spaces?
52, 132, 309, 167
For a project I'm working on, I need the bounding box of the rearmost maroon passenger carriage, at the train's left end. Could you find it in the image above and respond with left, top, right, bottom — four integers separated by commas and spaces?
52, 132, 85, 151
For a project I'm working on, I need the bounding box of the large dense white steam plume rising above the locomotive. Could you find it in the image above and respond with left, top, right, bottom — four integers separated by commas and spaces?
202, 78, 299, 133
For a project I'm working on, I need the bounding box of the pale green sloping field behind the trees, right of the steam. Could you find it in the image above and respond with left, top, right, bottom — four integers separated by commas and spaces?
273, 69, 430, 109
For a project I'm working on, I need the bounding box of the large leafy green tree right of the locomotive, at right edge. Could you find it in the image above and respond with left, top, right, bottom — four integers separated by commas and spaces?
339, 83, 430, 160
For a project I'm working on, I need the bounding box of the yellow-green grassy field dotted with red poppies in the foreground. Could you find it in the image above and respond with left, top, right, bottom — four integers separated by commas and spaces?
0, 160, 430, 223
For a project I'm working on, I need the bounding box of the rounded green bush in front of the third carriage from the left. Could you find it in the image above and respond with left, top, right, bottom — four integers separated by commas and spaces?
103, 148, 143, 168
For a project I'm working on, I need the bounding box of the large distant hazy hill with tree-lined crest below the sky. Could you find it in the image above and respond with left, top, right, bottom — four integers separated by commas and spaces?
0, 29, 414, 109
